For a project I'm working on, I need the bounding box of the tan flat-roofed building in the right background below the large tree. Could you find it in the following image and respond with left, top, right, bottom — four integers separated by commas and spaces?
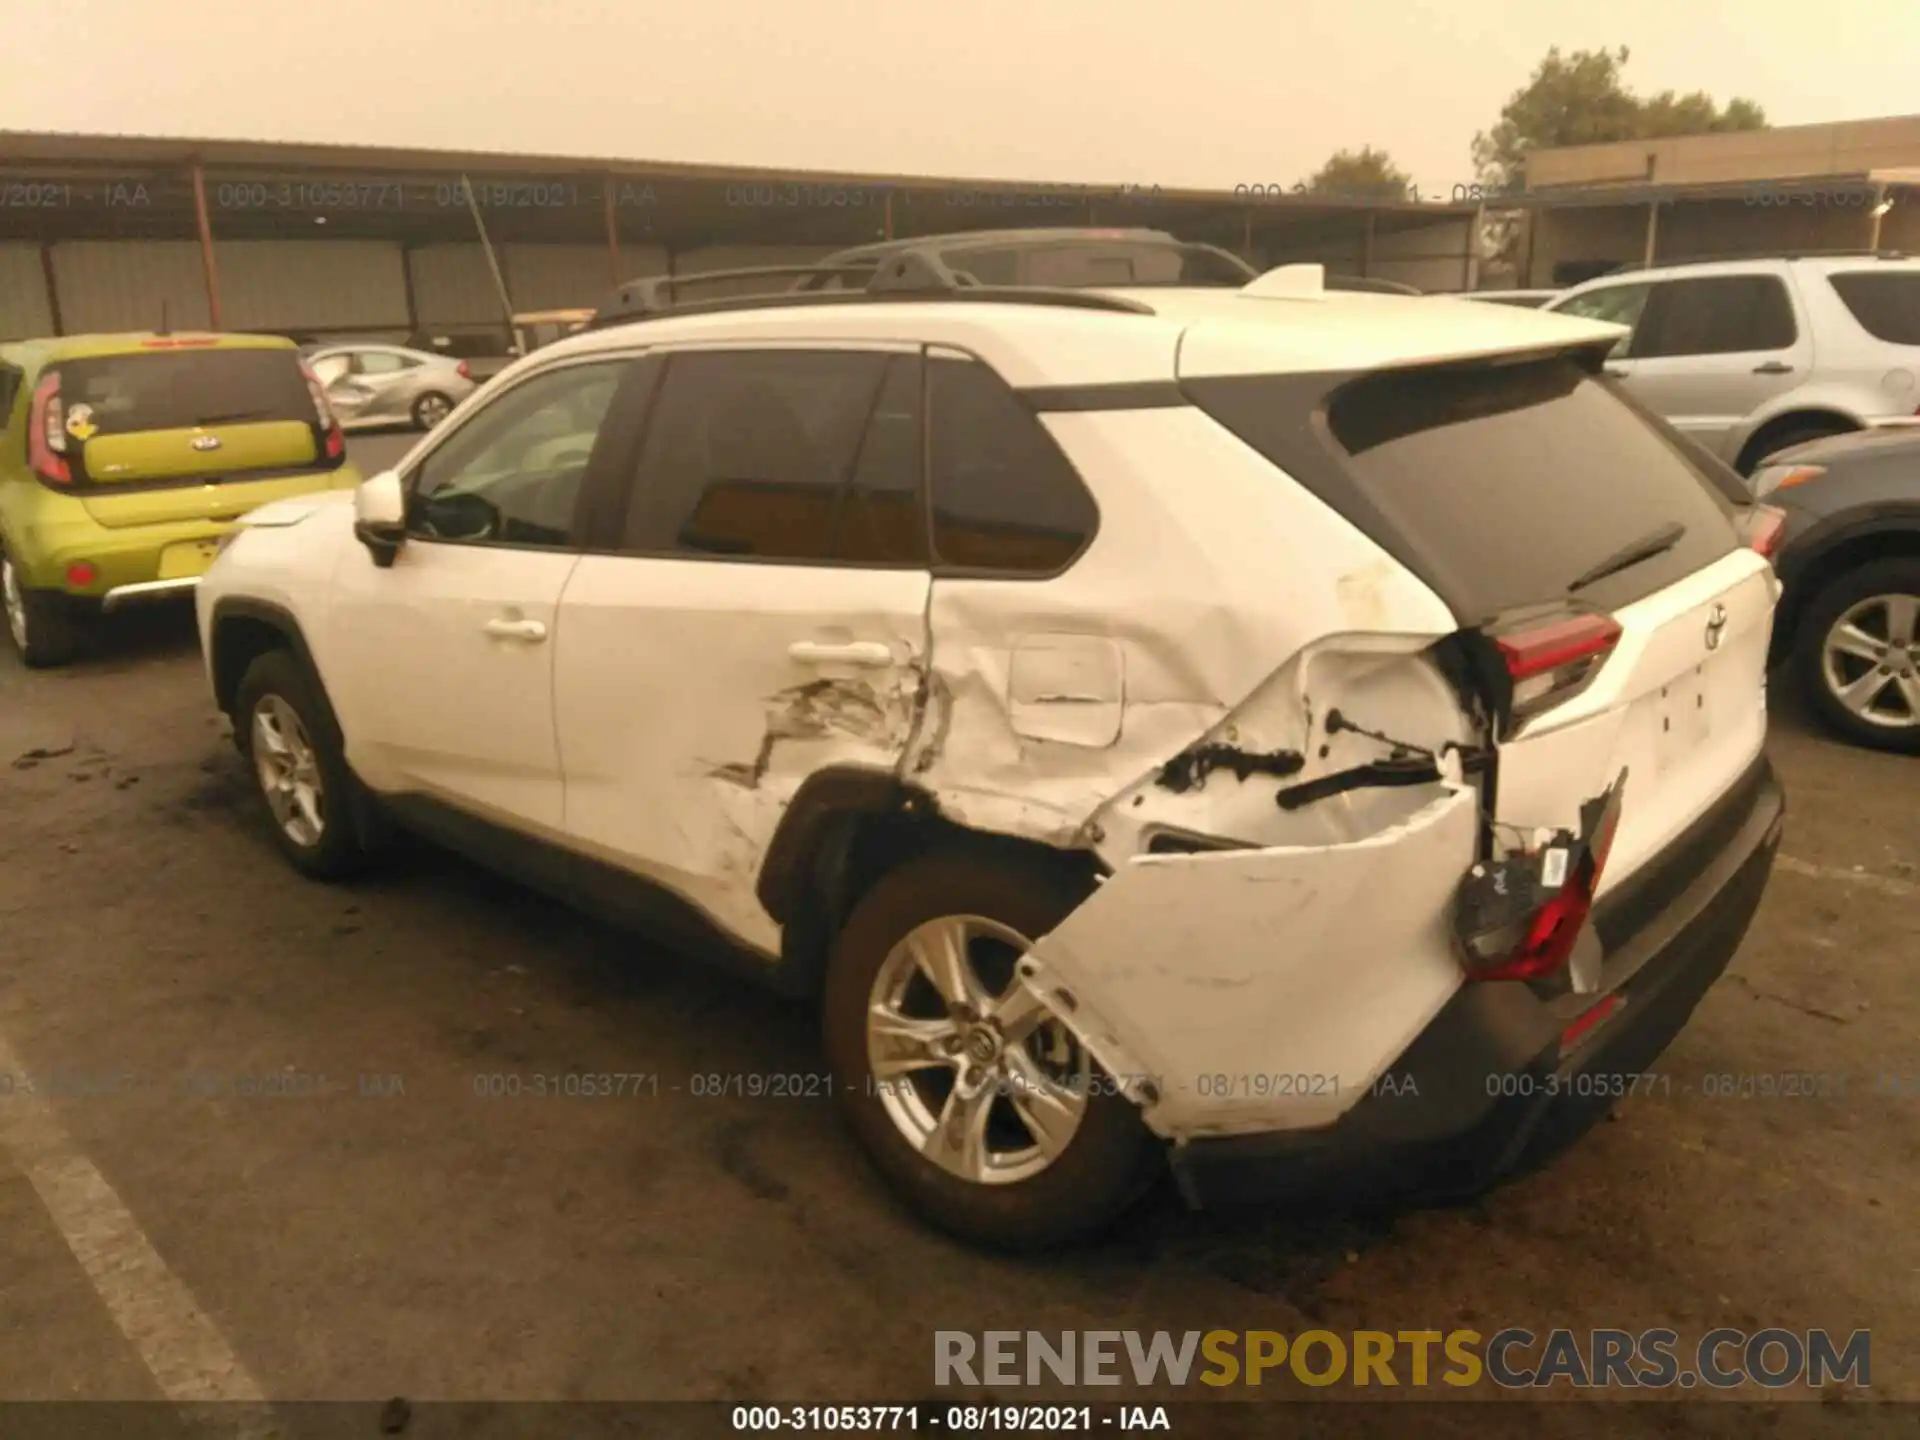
1517, 115, 1920, 286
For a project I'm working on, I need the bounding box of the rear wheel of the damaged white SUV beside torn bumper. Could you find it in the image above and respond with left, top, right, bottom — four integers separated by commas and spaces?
822, 851, 1162, 1250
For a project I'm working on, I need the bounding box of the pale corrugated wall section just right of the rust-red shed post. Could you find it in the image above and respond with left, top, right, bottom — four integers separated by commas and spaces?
213, 240, 407, 334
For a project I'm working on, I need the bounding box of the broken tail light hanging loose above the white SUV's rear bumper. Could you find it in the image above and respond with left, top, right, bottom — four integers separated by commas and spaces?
1453, 770, 1626, 979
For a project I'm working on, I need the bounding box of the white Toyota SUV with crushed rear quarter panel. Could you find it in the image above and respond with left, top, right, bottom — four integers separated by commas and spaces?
198, 250, 1784, 1248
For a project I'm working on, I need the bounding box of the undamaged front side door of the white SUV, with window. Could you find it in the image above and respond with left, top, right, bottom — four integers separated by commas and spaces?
328, 359, 630, 833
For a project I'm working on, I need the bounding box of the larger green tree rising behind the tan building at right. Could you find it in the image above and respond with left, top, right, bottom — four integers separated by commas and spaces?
1473, 44, 1766, 190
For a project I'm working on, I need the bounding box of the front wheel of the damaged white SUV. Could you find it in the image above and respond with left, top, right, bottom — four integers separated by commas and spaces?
234, 651, 372, 879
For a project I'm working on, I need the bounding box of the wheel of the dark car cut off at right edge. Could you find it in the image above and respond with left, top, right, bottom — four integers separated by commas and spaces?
1793, 557, 1920, 755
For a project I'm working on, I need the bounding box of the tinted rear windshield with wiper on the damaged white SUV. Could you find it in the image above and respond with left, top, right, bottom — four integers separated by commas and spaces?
1187, 359, 1738, 624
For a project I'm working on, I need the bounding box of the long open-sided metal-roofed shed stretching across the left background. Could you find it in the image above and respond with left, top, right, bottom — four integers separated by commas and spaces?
0, 131, 1480, 346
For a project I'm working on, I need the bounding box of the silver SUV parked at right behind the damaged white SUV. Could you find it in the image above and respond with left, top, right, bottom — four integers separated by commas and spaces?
1546, 253, 1920, 474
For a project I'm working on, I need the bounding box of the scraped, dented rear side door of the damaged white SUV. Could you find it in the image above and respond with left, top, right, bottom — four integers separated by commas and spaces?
555, 344, 931, 952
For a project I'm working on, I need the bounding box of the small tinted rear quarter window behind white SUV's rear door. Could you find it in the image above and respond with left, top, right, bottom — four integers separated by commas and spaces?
927, 359, 1100, 574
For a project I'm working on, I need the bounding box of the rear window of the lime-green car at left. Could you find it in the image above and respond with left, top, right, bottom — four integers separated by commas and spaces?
60, 349, 313, 436
